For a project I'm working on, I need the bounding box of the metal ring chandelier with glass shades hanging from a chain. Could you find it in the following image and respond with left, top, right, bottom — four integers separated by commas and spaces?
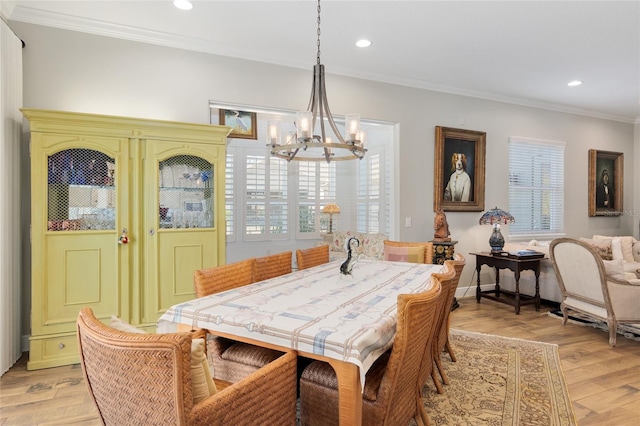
267, 0, 367, 163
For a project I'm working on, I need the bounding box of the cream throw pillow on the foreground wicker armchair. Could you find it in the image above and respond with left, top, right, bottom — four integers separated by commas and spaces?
109, 315, 217, 404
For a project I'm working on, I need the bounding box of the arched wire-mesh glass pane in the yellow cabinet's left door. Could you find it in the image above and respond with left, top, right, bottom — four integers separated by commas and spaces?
47, 148, 116, 231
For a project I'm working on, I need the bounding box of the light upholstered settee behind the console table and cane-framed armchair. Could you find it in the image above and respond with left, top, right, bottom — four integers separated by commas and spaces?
500, 235, 640, 303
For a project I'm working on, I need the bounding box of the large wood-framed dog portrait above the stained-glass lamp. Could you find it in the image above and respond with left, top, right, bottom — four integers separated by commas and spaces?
433, 126, 487, 212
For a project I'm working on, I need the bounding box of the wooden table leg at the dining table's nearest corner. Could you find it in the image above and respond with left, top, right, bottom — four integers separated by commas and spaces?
329, 359, 362, 426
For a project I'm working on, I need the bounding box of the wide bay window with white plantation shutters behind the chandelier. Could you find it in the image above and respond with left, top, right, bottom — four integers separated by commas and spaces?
211, 104, 394, 245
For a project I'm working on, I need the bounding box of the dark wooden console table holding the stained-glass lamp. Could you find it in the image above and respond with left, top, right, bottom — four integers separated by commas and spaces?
470, 252, 544, 315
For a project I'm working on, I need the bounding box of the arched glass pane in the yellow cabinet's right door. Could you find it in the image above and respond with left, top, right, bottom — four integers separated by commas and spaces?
158, 155, 214, 228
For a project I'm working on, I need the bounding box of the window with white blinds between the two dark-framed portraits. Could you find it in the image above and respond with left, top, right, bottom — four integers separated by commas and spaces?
509, 137, 565, 238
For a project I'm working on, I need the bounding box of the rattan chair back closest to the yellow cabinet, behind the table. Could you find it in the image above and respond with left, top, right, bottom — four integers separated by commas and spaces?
193, 258, 256, 297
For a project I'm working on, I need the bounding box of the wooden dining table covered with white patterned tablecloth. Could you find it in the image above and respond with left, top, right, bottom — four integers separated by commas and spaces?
157, 260, 443, 425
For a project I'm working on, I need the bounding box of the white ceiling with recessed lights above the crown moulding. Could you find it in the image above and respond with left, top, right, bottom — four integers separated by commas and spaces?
5, 0, 640, 123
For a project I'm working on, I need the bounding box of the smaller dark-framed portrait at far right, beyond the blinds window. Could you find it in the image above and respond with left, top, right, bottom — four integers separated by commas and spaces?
589, 149, 624, 216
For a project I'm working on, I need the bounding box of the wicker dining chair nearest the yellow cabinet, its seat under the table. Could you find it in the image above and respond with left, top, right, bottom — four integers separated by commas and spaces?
193, 258, 282, 383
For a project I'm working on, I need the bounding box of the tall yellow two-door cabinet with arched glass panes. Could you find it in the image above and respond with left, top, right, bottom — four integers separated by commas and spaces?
22, 109, 229, 369
